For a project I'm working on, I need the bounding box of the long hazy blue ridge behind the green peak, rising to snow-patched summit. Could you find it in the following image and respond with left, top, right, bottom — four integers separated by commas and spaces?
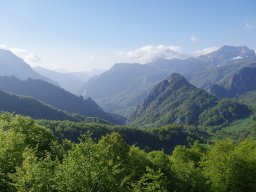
83, 45, 256, 116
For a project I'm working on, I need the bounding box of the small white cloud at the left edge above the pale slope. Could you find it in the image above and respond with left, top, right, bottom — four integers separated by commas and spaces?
0, 44, 40, 64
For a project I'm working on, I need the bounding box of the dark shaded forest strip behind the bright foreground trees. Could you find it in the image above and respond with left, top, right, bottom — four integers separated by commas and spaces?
37, 120, 208, 153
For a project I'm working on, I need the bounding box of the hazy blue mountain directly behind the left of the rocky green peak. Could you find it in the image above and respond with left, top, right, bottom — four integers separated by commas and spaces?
83, 63, 165, 114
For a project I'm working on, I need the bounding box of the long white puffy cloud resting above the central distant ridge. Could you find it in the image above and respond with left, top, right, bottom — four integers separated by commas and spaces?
119, 45, 182, 63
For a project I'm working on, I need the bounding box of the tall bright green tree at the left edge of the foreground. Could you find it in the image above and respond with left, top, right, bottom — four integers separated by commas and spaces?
0, 113, 58, 191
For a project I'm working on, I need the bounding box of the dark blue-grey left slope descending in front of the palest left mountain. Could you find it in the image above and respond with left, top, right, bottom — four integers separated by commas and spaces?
0, 77, 124, 124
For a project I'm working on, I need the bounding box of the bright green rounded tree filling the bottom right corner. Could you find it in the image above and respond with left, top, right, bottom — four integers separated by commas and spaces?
201, 139, 256, 192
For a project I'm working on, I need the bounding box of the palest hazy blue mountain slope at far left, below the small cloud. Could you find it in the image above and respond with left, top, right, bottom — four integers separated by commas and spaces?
0, 49, 57, 85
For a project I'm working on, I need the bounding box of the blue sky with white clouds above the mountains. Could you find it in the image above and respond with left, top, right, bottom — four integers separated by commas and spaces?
0, 0, 256, 71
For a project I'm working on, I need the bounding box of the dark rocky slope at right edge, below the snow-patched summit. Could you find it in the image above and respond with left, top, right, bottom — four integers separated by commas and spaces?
209, 63, 256, 97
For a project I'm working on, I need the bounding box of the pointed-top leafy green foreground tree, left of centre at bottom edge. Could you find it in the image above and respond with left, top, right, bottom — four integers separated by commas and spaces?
56, 134, 125, 192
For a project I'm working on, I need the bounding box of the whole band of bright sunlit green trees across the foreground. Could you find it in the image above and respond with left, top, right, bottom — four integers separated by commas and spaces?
0, 113, 256, 192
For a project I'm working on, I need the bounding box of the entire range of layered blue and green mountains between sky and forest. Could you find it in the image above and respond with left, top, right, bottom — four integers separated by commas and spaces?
0, 46, 256, 126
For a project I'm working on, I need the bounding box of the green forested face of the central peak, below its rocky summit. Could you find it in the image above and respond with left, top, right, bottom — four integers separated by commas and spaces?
132, 82, 217, 127
